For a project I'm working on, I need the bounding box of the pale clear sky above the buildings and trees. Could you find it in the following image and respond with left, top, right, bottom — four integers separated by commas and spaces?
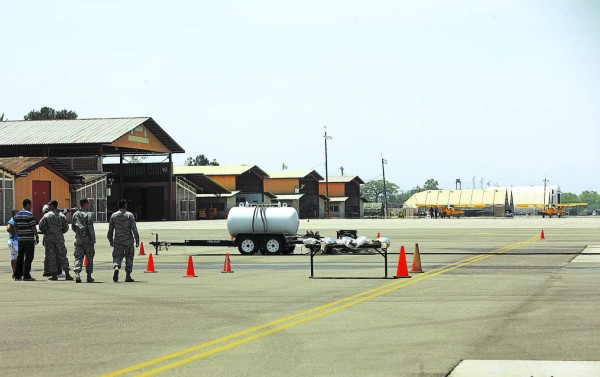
0, 0, 600, 192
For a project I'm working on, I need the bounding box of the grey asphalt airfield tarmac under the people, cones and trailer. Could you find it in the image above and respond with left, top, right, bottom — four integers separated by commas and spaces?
0, 218, 600, 376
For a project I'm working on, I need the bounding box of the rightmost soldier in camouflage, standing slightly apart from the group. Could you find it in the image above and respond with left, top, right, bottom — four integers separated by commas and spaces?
108, 199, 140, 283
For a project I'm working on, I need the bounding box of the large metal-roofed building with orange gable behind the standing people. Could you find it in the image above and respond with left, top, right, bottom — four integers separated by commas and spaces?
0, 117, 229, 221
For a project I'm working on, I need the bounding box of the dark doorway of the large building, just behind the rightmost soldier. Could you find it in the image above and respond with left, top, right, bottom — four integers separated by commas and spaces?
124, 187, 165, 221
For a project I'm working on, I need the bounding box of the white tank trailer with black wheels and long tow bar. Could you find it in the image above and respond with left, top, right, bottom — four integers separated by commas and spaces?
150, 204, 302, 255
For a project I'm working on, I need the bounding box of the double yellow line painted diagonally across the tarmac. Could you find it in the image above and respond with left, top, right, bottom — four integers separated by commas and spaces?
101, 236, 540, 377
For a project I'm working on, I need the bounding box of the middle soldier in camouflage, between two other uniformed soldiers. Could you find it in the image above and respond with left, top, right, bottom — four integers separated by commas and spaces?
71, 198, 96, 283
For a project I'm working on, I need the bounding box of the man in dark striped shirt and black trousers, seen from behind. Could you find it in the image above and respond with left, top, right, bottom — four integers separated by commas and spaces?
14, 199, 40, 281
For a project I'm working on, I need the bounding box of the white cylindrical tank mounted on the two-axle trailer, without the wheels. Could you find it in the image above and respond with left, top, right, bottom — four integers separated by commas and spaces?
227, 207, 300, 237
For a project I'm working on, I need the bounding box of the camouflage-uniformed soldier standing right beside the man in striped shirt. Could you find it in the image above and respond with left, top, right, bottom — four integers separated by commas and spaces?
39, 200, 73, 280
